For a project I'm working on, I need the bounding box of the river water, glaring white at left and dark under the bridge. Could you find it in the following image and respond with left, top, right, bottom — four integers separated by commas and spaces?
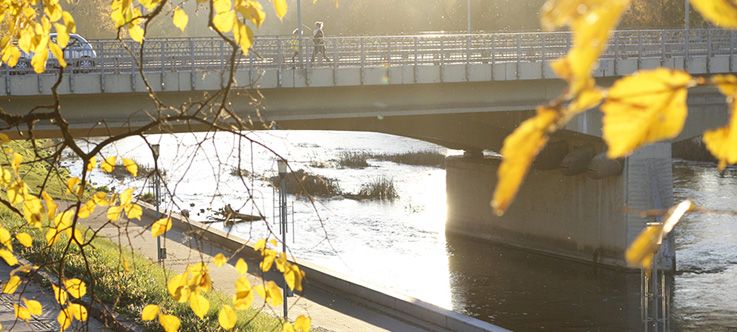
70, 131, 737, 331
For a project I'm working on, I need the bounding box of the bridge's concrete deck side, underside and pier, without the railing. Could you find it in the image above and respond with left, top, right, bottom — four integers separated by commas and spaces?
0, 80, 727, 266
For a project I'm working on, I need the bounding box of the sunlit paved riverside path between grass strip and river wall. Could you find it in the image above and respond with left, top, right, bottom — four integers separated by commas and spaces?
86, 208, 432, 332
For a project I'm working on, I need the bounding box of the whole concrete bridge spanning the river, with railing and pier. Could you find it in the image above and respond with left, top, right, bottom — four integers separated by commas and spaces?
0, 29, 724, 266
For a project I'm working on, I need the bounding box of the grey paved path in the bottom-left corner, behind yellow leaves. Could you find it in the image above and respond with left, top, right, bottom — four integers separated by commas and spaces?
0, 262, 109, 331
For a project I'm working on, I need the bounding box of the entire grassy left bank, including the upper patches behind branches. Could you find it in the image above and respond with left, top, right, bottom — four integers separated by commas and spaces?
0, 141, 280, 331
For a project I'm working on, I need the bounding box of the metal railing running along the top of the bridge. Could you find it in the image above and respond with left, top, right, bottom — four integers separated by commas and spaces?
4, 29, 737, 74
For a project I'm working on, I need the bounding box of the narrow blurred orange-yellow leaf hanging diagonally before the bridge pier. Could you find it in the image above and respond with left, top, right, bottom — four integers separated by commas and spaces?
491, 107, 559, 215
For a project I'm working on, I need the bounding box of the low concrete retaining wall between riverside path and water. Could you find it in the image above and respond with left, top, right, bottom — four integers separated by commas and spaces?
139, 202, 507, 331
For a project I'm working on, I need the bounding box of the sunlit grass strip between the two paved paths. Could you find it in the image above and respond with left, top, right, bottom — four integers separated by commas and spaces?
15, 218, 280, 331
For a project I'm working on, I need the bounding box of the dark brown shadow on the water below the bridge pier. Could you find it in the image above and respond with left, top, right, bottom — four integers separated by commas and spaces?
440, 234, 642, 331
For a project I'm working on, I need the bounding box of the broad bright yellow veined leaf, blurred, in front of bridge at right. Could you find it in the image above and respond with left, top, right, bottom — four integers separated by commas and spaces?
601, 68, 691, 159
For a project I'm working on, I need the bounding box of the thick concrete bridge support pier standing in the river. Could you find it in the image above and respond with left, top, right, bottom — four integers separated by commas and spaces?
446, 143, 675, 267
